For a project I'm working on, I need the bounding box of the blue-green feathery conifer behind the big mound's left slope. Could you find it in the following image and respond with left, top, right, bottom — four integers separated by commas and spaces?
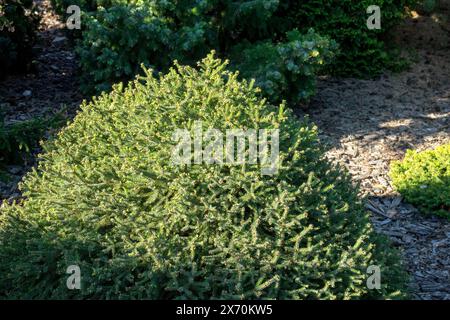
77, 1, 222, 93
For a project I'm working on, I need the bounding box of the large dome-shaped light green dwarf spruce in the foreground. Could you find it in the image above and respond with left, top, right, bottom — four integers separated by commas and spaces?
0, 55, 404, 299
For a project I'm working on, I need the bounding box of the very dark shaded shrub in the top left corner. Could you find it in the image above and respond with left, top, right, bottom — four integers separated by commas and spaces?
0, 0, 39, 79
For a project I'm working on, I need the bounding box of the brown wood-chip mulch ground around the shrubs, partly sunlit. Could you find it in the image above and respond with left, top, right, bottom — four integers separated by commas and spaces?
0, 0, 450, 299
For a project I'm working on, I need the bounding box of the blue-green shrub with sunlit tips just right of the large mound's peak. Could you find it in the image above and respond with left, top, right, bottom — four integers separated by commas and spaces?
231, 29, 337, 105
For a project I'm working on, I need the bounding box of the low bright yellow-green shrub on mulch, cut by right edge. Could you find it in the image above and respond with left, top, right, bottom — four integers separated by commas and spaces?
390, 144, 450, 218
